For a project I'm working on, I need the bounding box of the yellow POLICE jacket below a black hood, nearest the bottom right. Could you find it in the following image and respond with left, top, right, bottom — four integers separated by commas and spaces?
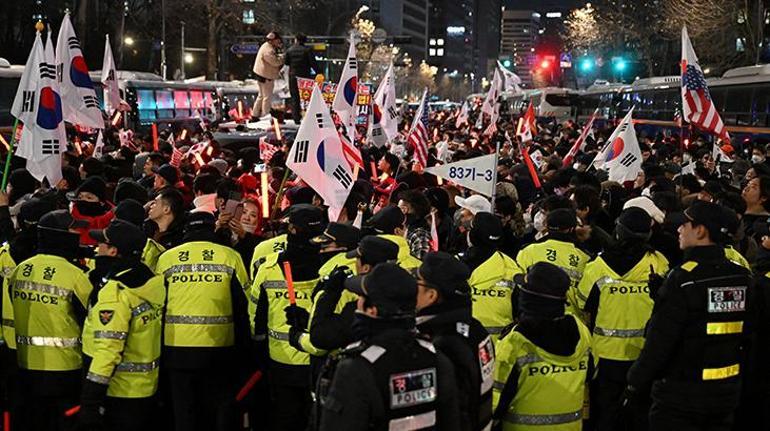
492, 314, 591, 431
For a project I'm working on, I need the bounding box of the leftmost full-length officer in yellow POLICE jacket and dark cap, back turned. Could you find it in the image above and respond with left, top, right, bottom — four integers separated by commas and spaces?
9, 210, 91, 431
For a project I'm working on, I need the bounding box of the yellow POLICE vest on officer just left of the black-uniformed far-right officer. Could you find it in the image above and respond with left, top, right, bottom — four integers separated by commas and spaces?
577, 251, 668, 361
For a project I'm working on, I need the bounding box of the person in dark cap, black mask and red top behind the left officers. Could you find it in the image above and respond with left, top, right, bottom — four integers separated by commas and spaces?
67, 177, 115, 245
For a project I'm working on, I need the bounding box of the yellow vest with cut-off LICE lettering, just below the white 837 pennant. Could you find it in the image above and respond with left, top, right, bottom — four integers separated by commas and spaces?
468, 251, 522, 340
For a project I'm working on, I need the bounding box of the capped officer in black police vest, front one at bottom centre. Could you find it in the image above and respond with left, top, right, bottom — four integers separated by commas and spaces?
320, 263, 460, 431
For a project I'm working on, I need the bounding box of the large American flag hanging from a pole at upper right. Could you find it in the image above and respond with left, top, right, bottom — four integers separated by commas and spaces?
681, 27, 730, 142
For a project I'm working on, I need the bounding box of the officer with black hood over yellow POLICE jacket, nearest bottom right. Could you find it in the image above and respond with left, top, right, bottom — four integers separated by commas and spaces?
493, 262, 591, 430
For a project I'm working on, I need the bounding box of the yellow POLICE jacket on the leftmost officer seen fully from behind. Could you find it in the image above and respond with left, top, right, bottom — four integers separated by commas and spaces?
10, 254, 91, 371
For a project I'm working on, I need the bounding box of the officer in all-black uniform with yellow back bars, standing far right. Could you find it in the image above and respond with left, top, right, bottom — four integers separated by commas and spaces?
626, 201, 753, 430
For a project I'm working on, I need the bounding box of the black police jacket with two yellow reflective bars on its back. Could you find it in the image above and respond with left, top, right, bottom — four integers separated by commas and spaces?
627, 245, 755, 413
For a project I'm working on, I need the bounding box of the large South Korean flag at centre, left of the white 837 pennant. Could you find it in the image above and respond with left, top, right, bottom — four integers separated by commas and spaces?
286, 85, 354, 221
